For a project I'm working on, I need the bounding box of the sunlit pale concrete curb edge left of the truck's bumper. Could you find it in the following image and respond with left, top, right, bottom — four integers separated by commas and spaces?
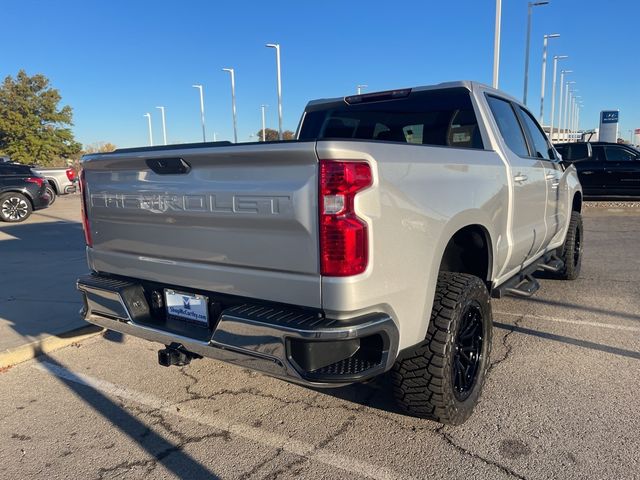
0, 325, 104, 369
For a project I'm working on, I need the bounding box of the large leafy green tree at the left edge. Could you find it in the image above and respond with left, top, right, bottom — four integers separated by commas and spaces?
0, 70, 81, 165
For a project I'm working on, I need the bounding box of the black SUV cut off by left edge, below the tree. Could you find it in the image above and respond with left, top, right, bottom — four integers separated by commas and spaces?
0, 159, 49, 222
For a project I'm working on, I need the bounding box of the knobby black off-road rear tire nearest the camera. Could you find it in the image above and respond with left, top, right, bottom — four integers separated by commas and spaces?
391, 272, 492, 425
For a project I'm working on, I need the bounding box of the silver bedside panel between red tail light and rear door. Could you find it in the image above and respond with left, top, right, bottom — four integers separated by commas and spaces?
317, 140, 508, 349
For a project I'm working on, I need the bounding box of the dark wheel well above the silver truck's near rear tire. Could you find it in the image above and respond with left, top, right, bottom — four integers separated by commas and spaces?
440, 225, 493, 282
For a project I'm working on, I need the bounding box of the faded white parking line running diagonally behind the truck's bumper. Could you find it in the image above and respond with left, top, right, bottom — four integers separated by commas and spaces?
33, 362, 411, 480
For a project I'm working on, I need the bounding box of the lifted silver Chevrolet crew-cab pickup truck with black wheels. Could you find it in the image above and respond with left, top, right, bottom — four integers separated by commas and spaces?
78, 82, 583, 424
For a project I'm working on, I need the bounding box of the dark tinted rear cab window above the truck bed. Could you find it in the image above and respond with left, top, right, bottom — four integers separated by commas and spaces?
298, 87, 484, 149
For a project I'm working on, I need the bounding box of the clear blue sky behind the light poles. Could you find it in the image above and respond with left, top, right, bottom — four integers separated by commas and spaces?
0, 0, 640, 147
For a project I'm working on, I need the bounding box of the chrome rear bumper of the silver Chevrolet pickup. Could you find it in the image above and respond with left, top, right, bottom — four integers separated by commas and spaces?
77, 274, 398, 387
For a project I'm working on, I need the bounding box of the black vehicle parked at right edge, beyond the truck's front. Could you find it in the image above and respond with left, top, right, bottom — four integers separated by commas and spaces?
554, 142, 640, 197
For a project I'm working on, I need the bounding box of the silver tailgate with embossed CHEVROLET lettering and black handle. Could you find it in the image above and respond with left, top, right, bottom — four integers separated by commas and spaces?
83, 142, 320, 307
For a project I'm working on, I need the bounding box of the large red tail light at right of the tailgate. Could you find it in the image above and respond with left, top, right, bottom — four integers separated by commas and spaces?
319, 160, 372, 277
